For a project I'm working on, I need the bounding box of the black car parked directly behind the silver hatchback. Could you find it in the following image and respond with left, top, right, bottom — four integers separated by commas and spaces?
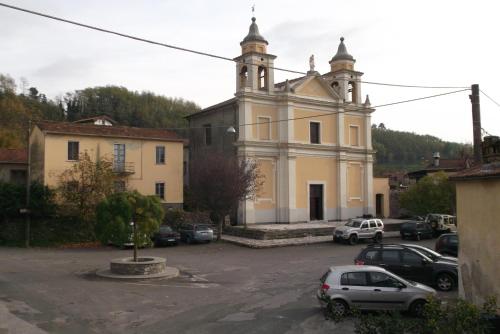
354, 244, 458, 291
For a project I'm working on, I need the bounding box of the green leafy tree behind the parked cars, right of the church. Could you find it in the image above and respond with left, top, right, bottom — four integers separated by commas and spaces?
400, 172, 456, 215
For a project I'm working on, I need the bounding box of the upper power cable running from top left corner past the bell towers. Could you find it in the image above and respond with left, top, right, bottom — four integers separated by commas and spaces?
0, 2, 472, 87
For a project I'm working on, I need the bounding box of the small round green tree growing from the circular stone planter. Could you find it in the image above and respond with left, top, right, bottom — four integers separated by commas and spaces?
95, 191, 164, 261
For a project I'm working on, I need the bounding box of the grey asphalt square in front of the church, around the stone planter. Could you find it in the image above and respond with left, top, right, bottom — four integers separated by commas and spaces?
0, 239, 456, 334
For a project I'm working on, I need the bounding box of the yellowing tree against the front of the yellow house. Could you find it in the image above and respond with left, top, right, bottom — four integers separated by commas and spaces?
58, 152, 121, 228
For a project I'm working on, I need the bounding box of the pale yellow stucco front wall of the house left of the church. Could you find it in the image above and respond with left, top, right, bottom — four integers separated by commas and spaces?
44, 134, 183, 203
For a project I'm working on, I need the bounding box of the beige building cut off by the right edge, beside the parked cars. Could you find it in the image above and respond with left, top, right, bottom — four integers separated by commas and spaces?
450, 137, 500, 304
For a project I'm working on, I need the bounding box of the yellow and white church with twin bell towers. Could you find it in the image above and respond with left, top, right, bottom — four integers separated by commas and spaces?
188, 18, 378, 224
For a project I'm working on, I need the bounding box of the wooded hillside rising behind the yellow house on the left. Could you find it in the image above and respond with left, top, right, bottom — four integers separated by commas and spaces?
0, 74, 200, 148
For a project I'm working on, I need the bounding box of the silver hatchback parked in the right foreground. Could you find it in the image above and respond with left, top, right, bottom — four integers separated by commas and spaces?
316, 265, 436, 316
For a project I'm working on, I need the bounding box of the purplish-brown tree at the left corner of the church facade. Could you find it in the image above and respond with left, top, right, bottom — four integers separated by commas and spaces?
188, 153, 263, 240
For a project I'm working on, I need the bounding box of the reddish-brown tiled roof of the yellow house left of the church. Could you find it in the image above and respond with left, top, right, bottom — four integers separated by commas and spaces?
36, 121, 183, 141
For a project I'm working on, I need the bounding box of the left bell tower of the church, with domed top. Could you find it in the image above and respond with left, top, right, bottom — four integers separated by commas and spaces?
234, 17, 276, 93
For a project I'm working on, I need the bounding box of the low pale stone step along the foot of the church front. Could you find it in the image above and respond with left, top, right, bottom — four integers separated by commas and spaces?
222, 231, 399, 249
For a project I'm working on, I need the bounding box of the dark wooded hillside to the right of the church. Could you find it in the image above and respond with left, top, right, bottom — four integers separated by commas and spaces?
372, 123, 472, 174
